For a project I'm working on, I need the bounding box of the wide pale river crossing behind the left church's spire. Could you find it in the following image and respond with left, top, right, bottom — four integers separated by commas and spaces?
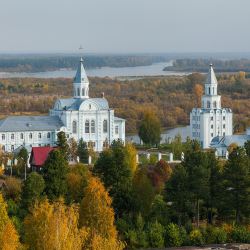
0, 61, 188, 78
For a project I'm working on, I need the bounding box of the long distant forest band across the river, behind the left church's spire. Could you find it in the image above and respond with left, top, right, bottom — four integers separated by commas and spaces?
0, 54, 170, 72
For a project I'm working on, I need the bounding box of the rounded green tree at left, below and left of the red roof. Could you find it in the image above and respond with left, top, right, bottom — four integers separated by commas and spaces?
22, 172, 45, 210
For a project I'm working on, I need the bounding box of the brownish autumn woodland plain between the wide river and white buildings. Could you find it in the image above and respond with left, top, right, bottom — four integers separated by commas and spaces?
0, 72, 250, 133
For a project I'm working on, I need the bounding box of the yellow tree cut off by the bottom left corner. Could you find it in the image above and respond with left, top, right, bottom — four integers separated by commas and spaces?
0, 193, 20, 250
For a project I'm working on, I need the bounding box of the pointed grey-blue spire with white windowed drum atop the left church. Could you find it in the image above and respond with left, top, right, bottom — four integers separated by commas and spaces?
73, 57, 89, 98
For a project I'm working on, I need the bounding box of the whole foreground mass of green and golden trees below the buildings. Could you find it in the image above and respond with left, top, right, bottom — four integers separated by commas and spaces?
0, 132, 250, 250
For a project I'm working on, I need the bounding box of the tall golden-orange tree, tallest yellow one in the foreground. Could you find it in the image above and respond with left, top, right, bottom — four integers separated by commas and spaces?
80, 177, 124, 250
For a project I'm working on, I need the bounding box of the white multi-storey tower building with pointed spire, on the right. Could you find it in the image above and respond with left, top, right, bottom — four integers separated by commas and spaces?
190, 64, 233, 149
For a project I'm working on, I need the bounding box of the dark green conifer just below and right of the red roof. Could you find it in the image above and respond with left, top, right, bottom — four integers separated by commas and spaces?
42, 150, 68, 199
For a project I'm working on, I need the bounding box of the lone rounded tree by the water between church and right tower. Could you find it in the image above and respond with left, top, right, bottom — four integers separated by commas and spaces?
138, 112, 161, 145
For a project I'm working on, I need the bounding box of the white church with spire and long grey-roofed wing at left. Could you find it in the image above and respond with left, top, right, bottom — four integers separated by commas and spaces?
0, 59, 125, 152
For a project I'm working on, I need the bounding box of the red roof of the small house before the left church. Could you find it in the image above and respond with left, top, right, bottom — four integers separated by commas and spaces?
30, 147, 55, 166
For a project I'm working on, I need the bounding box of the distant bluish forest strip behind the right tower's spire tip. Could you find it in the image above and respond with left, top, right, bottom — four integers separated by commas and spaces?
164, 59, 250, 72
